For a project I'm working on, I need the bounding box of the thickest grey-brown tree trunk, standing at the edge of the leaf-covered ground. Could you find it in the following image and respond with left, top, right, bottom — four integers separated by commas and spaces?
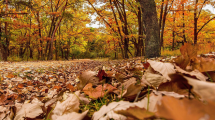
141, 0, 160, 58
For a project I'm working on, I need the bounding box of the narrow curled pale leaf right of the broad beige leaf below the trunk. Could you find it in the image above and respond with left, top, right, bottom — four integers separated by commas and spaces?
175, 66, 208, 81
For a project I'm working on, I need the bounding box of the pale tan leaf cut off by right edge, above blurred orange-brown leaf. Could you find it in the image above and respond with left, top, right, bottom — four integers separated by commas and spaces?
184, 76, 215, 101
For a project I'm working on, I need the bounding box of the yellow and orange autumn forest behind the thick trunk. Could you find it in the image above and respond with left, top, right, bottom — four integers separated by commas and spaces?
0, 0, 215, 61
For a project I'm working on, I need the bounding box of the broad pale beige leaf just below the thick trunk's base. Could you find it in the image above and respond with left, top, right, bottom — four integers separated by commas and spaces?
147, 60, 176, 80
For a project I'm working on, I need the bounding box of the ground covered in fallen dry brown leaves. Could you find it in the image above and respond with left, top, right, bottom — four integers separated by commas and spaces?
0, 43, 215, 120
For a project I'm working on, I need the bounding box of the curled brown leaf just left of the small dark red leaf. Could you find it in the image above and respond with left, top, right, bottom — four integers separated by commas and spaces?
77, 71, 99, 90
